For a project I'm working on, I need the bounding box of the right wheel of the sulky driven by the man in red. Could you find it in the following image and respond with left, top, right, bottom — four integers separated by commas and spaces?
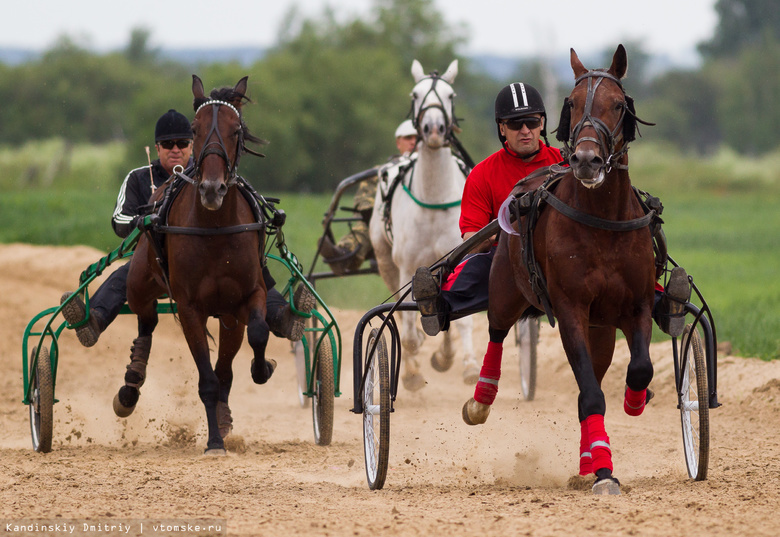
680, 324, 710, 481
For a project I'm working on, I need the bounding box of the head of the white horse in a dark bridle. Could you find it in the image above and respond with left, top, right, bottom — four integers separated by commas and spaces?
411, 60, 458, 149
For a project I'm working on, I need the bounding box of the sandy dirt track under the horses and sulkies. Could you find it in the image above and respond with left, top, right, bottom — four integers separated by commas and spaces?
0, 244, 780, 537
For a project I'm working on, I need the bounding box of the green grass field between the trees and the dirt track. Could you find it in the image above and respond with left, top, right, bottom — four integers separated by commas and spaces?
0, 141, 780, 359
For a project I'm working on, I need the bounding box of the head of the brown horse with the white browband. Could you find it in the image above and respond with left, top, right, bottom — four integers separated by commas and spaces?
192, 75, 248, 211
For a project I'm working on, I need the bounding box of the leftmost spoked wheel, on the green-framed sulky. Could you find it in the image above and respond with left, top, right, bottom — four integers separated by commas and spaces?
29, 347, 54, 453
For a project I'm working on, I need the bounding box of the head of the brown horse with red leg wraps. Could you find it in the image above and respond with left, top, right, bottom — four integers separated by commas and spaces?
558, 45, 636, 188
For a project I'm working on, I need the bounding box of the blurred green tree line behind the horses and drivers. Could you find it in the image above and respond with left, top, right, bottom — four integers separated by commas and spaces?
0, 0, 780, 192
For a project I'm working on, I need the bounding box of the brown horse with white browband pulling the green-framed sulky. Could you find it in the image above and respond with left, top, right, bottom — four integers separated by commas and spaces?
114, 75, 276, 453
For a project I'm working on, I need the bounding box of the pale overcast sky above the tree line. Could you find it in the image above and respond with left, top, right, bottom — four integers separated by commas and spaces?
0, 0, 717, 62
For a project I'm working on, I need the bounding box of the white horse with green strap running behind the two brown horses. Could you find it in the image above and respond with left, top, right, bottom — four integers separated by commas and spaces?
369, 60, 479, 391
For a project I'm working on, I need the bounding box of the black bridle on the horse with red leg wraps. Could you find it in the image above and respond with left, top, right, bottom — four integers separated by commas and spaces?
563, 71, 637, 173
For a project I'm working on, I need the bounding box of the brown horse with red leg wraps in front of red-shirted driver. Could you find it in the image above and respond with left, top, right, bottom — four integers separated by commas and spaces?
463, 45, 655, 494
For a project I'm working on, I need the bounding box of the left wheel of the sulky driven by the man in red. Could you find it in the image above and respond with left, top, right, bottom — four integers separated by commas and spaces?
363, 328, 390, 490
